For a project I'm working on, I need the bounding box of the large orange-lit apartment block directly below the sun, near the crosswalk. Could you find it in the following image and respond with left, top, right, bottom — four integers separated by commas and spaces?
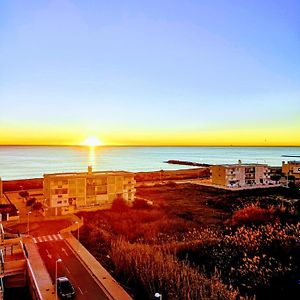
44, 167, 136, 215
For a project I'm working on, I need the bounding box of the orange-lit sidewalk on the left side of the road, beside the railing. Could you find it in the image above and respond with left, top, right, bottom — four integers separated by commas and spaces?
23, 237, 55, 300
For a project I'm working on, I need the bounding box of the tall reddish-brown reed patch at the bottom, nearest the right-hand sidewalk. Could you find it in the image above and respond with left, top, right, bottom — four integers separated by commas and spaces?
111, 239, 238, 300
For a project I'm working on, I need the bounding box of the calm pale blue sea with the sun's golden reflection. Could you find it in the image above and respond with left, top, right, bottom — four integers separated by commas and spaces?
0, 146, 300, 180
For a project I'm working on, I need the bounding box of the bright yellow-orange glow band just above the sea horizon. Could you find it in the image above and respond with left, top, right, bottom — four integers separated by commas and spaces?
0, 126, 300, 147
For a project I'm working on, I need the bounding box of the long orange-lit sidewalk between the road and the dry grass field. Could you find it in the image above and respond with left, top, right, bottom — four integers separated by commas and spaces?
61, 232, 132, 300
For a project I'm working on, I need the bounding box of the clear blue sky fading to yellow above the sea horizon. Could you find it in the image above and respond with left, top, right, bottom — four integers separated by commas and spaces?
0, 0, 300, 146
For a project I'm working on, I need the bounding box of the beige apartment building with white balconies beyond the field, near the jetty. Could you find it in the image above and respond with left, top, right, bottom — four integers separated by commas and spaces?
211, 161, 270, 187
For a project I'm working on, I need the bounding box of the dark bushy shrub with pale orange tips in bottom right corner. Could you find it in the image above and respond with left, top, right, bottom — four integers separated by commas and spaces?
210, 223, 300, 299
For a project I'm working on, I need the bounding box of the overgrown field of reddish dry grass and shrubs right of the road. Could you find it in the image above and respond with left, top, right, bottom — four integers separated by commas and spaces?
80, 184, 300, 300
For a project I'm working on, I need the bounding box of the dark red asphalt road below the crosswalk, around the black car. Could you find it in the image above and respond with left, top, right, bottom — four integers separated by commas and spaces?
36, 240, 108, 300
